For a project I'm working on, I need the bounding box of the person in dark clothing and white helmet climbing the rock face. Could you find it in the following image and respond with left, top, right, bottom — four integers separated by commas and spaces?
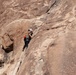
23, 29, 33, 51
